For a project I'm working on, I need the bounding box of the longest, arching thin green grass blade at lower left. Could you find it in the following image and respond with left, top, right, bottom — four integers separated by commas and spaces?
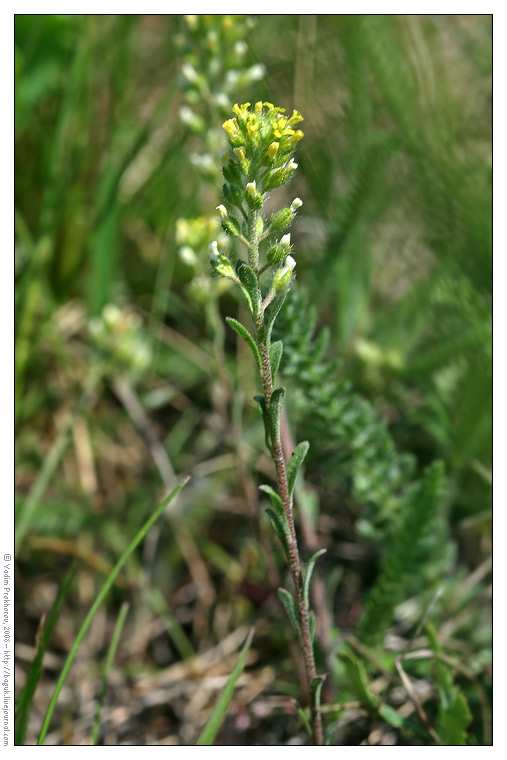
37, 477, 190, 745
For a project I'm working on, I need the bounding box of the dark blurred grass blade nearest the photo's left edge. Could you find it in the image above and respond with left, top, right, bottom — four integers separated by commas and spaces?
15, 562, 77, 746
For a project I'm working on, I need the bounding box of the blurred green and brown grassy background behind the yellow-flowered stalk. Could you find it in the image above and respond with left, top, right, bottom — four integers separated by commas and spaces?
15, 15, 492, 744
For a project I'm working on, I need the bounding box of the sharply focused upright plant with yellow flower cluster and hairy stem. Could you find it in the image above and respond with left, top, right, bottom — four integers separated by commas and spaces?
209, 102, 324, 745
